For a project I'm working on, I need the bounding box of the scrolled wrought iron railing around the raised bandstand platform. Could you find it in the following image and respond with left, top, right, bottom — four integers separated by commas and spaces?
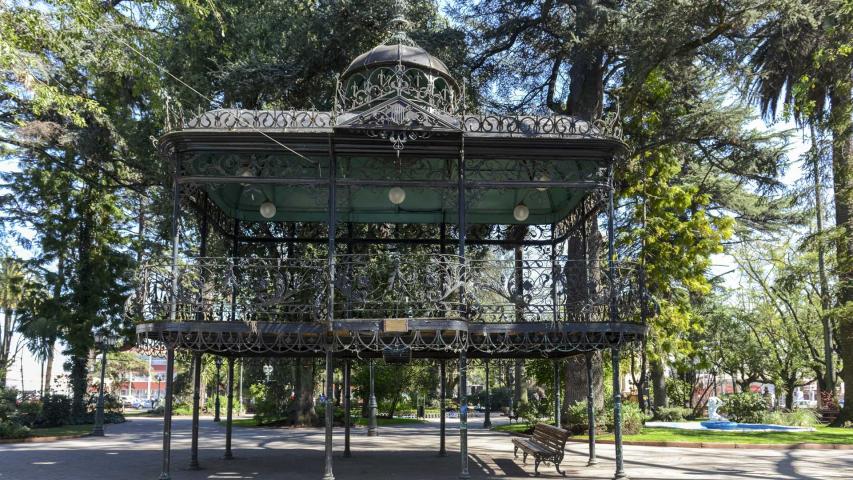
127, 252, 640, 323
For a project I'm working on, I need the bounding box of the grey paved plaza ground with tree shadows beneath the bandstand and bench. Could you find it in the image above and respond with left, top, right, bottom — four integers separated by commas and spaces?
0, 418, 853, 480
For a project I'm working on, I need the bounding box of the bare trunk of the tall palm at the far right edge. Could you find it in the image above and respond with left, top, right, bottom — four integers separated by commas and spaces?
829, 84, 853, 424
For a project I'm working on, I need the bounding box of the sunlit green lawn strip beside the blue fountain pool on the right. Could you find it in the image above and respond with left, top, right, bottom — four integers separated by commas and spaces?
495, 423, 853, 445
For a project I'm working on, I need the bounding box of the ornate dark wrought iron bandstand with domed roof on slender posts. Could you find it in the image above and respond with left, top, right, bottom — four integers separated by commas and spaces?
135, 7, 647, 479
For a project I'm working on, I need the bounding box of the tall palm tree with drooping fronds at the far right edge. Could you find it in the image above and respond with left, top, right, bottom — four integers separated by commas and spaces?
748, 0, 853, 423
